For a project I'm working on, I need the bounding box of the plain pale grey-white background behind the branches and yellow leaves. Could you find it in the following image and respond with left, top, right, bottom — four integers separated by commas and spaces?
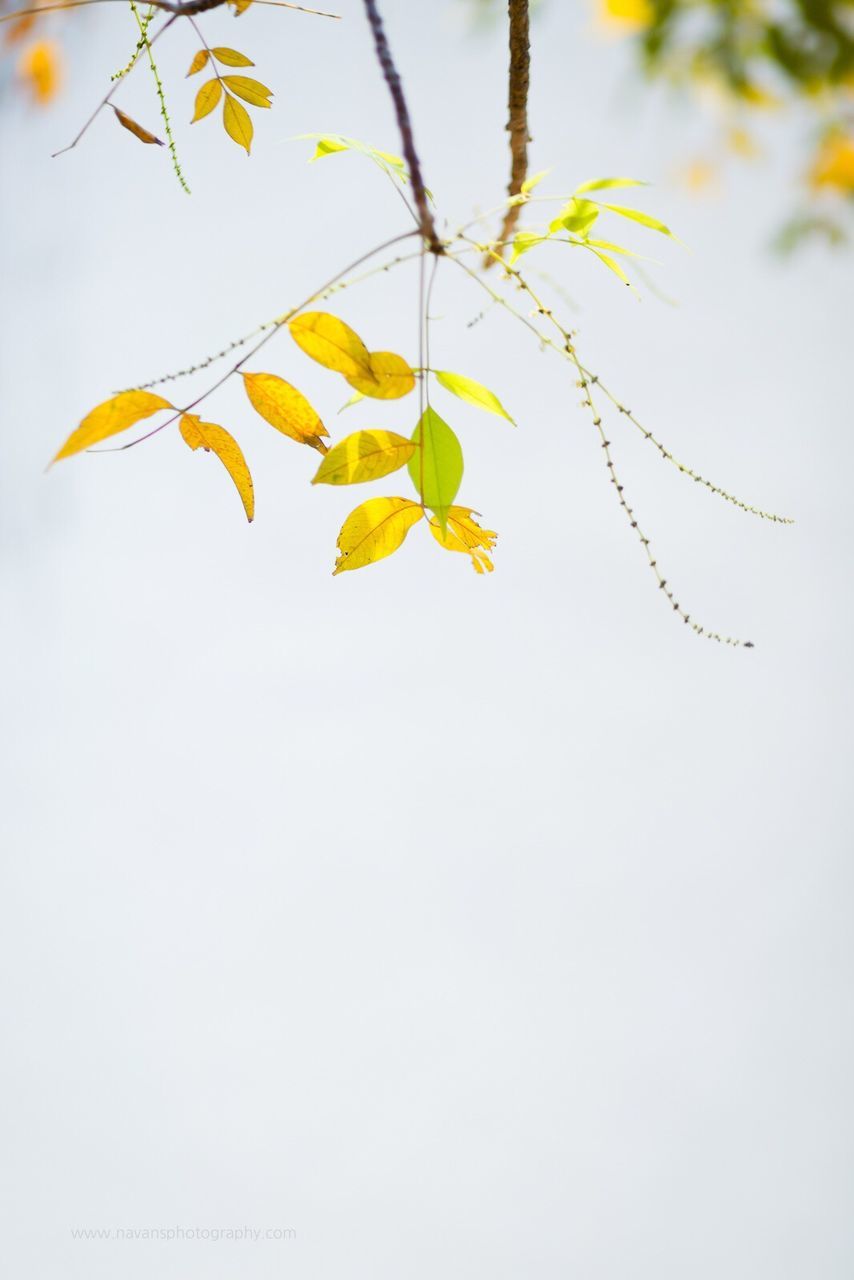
0, 0, 854, 1280
